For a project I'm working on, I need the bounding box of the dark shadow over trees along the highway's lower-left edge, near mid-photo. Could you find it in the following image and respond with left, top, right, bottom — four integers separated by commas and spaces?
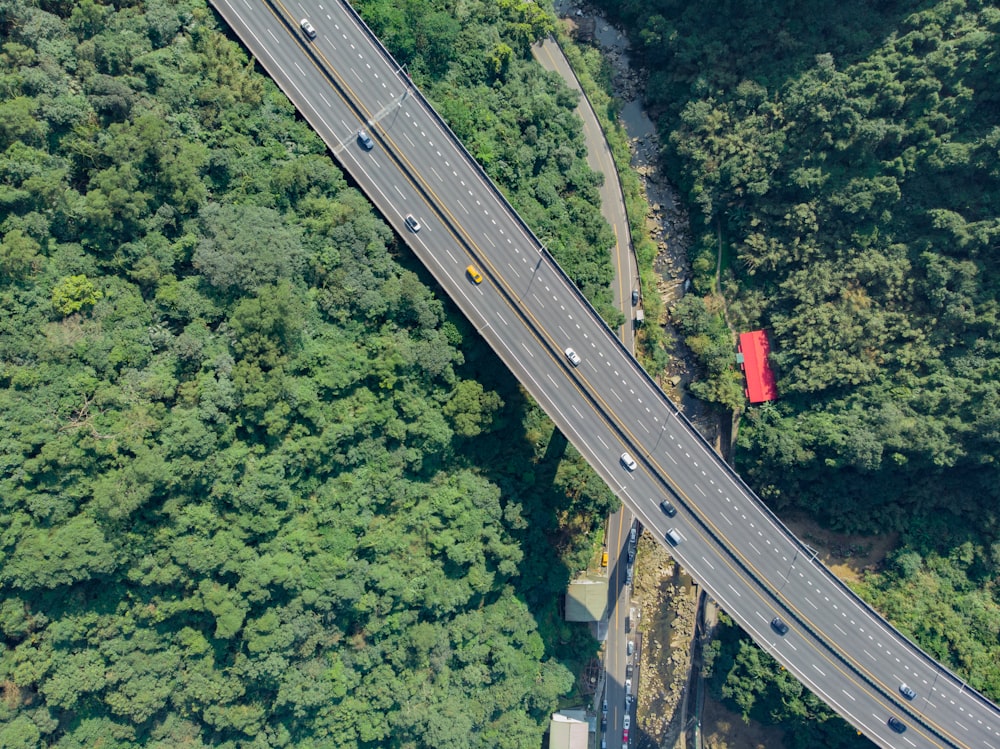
384, 240, 617, 696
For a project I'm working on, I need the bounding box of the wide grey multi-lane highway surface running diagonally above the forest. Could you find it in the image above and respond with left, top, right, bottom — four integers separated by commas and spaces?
205, 0, 1000, 749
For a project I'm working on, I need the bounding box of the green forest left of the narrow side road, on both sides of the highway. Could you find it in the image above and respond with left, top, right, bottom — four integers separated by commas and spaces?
0, 0, 613, 749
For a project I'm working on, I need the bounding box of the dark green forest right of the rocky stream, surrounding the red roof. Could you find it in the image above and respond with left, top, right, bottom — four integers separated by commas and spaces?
598, 0, 1000, 745
